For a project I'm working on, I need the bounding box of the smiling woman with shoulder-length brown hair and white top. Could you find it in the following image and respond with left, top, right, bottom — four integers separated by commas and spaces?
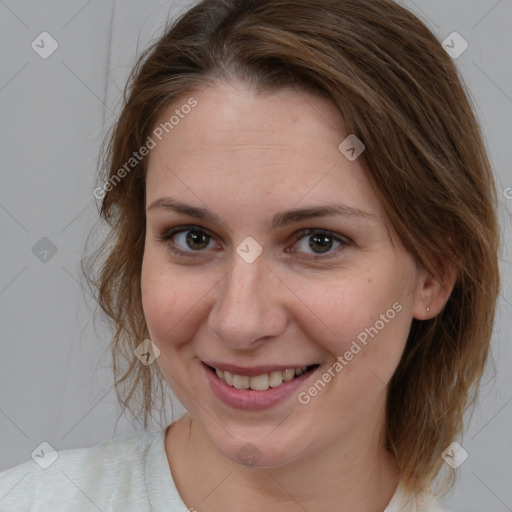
0, 0, 499, 512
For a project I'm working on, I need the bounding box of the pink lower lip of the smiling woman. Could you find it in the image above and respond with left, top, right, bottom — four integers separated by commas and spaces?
202, 363, 319, 411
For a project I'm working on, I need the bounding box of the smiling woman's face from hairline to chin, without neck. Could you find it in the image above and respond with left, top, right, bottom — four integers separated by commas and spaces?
142, 83, 425, 467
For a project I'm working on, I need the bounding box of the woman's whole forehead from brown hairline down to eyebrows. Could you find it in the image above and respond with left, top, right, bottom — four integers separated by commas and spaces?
146, 83, 381, 222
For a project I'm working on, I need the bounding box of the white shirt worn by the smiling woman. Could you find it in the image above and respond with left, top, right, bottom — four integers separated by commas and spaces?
0, 428, 447, 512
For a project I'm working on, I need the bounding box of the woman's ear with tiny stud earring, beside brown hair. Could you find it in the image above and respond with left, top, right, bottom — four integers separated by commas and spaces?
413, 263, 457, 320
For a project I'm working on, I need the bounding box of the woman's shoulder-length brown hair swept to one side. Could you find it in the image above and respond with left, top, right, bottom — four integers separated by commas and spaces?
84, 0, 500, 498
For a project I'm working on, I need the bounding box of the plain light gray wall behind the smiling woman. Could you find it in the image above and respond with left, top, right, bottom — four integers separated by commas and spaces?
0, 0, 512, 512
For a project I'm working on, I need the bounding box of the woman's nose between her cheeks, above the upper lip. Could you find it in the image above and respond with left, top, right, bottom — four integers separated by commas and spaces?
208, 252, 290, 351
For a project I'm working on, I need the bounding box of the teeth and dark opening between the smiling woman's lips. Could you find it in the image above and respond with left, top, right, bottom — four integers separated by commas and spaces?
205, 364, 319, 391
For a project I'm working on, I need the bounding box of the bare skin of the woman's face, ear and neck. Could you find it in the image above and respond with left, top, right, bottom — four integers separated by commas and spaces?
141, 82, 454, 512
